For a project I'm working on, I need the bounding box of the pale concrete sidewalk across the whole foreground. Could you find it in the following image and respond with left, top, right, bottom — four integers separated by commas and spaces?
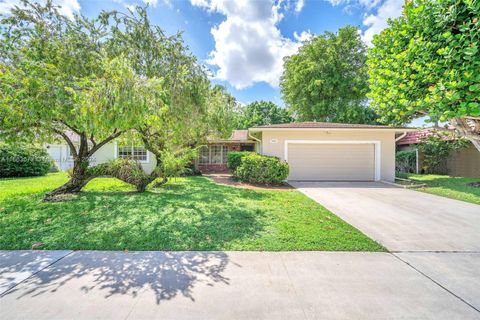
0, 251, 480, 319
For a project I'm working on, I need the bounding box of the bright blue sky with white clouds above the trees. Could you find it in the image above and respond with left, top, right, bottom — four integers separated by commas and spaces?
0, 0, 404, 105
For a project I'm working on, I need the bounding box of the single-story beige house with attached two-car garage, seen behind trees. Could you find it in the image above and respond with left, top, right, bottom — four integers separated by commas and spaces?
47, 122, 415, 181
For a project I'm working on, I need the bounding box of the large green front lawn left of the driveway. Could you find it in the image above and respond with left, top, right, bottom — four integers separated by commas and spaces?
0, 173, 384, 251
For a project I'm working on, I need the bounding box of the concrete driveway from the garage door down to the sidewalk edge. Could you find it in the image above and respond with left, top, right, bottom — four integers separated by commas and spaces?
290, 181, 480, 252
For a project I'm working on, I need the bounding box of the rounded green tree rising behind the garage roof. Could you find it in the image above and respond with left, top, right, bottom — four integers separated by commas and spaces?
280, 26, 376, 123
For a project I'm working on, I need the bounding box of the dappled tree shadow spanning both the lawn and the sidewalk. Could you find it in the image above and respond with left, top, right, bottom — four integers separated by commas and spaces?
0, 178, 271, 304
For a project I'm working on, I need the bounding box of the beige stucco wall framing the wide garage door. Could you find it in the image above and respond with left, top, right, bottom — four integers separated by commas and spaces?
262, 129, 395, 181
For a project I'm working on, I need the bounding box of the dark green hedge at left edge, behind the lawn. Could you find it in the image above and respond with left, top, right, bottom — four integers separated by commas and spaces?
0, 144, 53, 178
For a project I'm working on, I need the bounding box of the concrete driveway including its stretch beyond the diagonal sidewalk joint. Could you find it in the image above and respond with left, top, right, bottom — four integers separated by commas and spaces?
290, 181, 480, 318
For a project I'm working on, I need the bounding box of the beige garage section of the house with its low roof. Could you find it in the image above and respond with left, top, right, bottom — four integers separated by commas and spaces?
249, 122, 415, 181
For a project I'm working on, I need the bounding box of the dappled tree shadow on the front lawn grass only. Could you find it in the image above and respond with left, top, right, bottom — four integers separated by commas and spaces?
0, 177, 271, 251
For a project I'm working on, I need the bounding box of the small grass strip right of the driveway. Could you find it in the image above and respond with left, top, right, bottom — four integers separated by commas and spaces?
402, 174, 480, 204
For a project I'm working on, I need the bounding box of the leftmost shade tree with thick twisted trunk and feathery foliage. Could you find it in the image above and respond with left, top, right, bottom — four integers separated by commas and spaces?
0, 1, 155, 196
